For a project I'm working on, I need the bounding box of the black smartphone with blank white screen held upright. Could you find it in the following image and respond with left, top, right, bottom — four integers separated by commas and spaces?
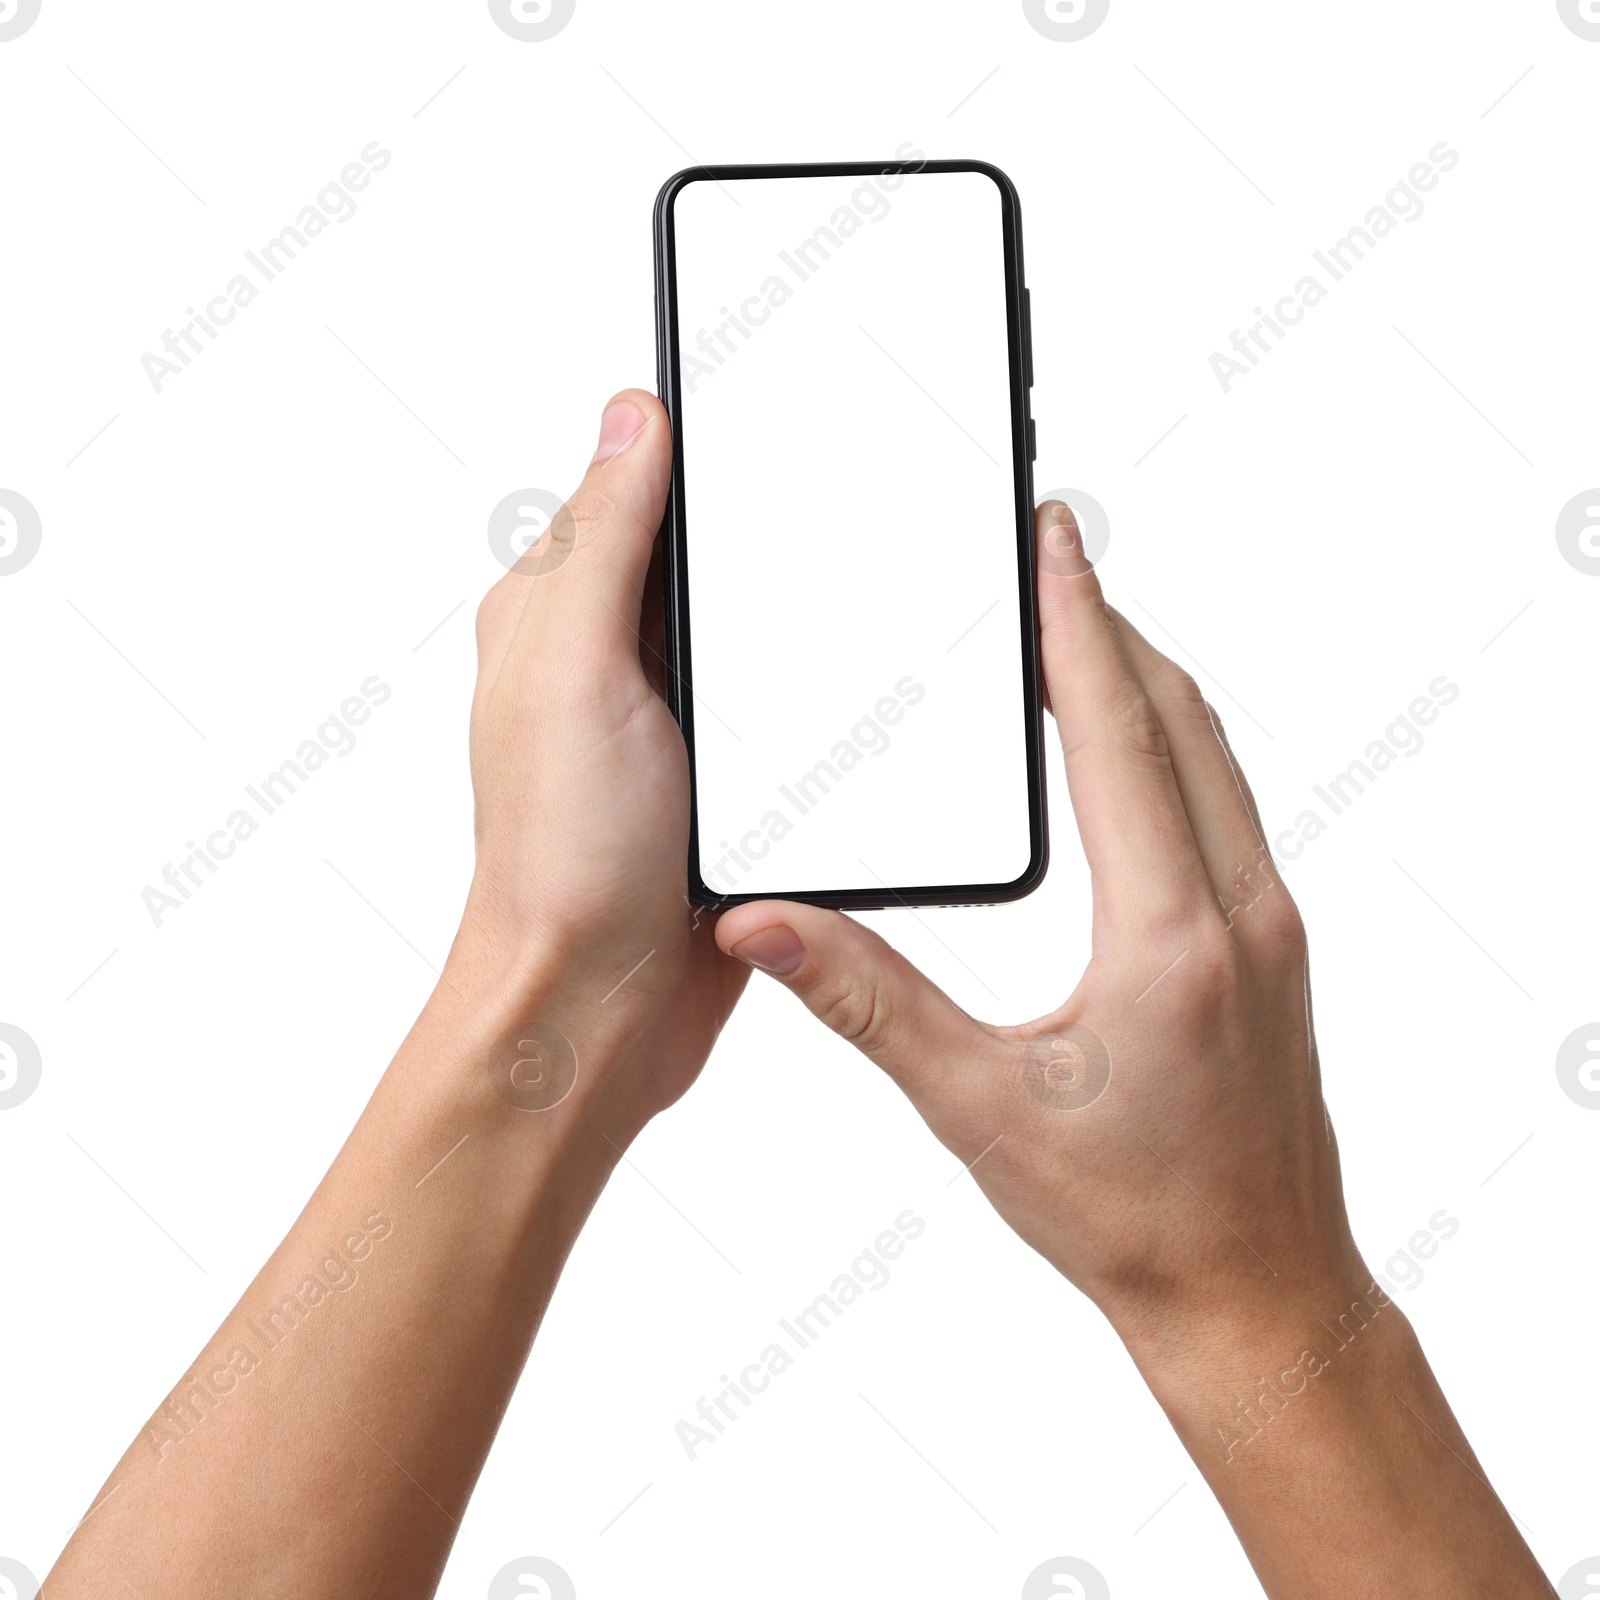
656, 160, 1048, 909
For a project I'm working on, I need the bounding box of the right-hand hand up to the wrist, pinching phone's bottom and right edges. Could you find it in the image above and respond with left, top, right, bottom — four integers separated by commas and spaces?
717, 502, 1371, 1355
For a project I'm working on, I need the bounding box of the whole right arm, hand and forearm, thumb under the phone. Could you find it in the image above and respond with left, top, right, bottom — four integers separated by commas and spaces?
717, 502, 1554, 1600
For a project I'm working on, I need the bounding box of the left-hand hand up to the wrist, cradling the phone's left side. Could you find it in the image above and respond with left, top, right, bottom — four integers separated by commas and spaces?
446, 389, 749, 1136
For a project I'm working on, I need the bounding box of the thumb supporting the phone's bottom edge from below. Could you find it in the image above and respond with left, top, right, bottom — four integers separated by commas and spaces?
717, 901, 990, 1104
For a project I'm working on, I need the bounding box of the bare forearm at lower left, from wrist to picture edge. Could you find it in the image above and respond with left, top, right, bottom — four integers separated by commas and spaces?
48, 947, 630, 1600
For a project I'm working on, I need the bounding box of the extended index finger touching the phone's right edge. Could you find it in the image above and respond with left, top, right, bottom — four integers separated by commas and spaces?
1037, 501, 1213, 922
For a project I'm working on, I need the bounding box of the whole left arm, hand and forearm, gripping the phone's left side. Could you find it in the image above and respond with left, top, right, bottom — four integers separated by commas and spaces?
48, 390, 732, 1600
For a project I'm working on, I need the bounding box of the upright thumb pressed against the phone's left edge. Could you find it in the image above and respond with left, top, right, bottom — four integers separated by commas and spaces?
514, 389, 672, 656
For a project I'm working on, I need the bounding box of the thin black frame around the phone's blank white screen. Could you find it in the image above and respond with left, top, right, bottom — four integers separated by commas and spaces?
654, 160, 1050, 910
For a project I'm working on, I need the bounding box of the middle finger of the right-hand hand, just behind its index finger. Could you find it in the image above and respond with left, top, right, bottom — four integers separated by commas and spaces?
1117, 613, 1267, 906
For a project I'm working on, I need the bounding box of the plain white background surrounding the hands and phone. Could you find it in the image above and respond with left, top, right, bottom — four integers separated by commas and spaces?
0, 0, 1600, 1600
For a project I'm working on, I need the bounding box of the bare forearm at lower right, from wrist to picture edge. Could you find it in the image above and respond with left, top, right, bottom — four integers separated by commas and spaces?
1130, 1274, 1552, 1600
